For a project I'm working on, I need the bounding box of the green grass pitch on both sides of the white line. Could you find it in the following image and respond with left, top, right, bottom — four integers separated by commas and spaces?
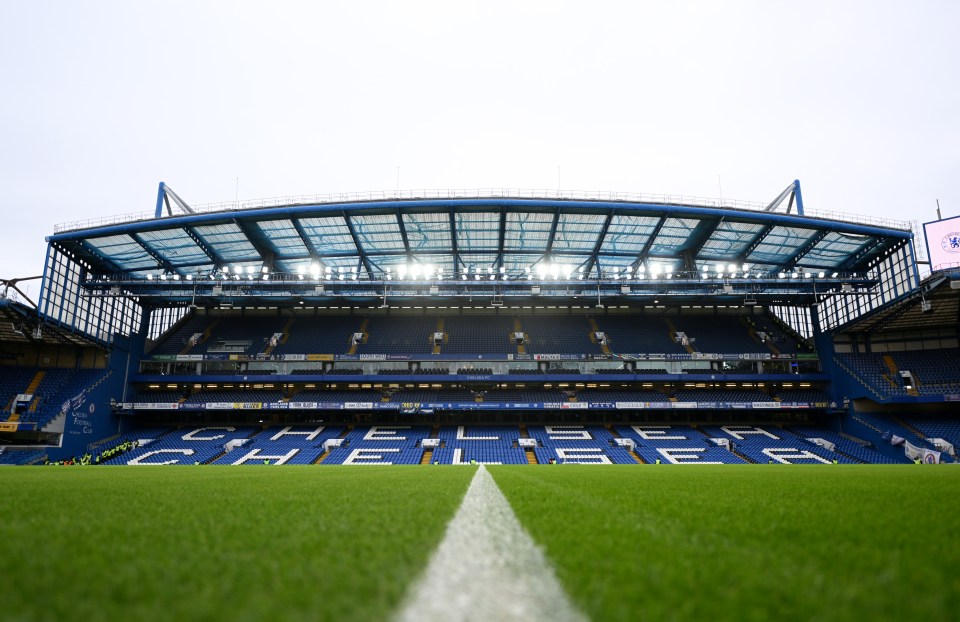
0, 465, 960, 621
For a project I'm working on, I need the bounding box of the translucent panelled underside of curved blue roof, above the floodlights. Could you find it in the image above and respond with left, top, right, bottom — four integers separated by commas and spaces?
48, 180, 910, 279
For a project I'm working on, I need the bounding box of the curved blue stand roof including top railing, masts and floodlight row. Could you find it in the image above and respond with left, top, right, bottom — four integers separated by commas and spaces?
47, 182, 913, 308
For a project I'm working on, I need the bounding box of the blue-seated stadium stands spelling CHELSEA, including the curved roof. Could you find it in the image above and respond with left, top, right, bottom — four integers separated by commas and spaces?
0, 182, 960, 465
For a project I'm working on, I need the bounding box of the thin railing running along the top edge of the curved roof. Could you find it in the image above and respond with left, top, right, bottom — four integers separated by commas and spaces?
54, 188, 913, 233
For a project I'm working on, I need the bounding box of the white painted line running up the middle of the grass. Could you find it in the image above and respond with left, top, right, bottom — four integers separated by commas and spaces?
396, 465, 586, 622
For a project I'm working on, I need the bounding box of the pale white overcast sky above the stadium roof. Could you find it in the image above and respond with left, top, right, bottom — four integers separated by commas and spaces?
0, 0, 960, 293
